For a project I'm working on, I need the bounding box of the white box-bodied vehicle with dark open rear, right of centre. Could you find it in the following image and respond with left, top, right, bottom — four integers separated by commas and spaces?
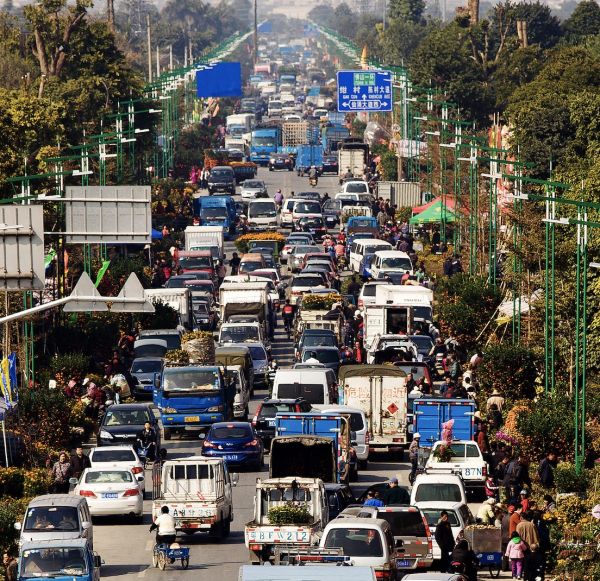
364, 284, 433, 348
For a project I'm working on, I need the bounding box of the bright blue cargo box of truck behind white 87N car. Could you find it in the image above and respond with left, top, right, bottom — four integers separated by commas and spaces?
412, 398, 476, 448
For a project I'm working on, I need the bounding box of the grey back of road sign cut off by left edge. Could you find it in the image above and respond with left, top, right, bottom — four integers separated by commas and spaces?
0, 205, 45, 291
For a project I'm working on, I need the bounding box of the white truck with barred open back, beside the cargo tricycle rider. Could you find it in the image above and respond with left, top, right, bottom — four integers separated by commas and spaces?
152, 456, 238, 540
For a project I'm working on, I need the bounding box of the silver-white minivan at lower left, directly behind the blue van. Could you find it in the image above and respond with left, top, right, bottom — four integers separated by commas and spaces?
15, 494, 94, 548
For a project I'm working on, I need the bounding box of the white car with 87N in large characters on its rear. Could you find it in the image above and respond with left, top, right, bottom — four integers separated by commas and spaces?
425, 440, 487, 488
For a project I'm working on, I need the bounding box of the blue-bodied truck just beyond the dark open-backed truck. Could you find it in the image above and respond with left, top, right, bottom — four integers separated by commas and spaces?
275, 413, 358, 482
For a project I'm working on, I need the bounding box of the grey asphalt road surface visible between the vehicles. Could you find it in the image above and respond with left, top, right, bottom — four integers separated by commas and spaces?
94, 169, 506, 581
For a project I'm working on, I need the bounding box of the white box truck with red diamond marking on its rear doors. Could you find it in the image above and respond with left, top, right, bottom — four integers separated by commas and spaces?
338, 365, 409, 453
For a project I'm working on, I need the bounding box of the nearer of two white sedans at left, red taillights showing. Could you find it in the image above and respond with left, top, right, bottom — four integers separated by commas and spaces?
73, 468, 144, 519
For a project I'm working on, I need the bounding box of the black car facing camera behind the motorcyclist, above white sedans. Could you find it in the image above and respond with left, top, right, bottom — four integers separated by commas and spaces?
98, 403, 160, 450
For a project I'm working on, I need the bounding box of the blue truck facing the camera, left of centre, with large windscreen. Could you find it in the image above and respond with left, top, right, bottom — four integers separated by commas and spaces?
152, 365, 235, 440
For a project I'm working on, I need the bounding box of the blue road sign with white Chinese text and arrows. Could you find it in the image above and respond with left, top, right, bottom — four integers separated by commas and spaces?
337, 70, 393, 113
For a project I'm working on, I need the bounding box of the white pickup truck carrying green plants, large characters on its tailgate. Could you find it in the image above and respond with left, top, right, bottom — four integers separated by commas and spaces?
244, 476, 329, 563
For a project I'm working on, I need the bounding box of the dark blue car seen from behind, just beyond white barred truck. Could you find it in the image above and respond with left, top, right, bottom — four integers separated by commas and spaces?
200, 422, 265, 470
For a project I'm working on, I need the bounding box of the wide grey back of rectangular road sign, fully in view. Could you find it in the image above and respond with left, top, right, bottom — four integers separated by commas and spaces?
64, 186, 152, 244
